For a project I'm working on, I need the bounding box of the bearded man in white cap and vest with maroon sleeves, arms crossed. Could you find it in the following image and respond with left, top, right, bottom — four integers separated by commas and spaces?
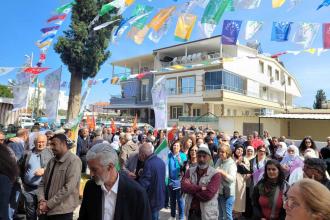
181, 146, 220, 220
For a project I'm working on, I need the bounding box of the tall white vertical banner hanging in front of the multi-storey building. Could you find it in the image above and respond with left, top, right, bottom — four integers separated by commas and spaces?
151, 76, 167, 129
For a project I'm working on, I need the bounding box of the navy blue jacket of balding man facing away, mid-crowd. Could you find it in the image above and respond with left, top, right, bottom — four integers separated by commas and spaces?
139, 154, 166, 212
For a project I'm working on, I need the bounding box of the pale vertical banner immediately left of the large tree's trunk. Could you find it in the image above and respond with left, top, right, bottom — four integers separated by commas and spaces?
45, 67, 62, 122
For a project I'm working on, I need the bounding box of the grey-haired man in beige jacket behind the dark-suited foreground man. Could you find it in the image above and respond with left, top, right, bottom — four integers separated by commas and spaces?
119, 133, 139, 168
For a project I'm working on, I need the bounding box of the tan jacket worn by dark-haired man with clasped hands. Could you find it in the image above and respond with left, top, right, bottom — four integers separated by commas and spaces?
37, 151, 81, 215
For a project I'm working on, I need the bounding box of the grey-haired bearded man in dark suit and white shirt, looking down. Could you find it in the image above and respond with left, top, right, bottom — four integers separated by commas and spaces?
78, 143, 151, 220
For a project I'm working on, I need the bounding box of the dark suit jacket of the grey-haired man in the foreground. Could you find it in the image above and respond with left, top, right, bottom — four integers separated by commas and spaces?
78, 173, 151, 220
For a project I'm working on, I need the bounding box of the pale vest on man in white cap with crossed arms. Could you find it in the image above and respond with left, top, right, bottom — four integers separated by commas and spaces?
182, 166, 219, 220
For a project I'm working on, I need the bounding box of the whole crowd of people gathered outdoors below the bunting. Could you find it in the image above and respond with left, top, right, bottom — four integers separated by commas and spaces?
0, 126, 330, 220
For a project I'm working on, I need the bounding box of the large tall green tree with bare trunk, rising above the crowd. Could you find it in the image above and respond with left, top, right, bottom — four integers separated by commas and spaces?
54, 0, 121, 120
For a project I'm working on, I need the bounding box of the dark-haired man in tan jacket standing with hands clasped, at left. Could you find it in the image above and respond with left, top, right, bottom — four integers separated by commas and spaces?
38, 134, 82, 220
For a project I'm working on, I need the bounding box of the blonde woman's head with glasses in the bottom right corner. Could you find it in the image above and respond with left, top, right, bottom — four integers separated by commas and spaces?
284, 179, 330, 220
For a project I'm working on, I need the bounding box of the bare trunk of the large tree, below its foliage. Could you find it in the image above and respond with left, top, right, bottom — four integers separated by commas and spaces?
67, 73, 82, 121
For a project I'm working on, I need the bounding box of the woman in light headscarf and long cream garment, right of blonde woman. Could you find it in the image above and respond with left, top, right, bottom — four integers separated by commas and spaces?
233, 144, 250, 218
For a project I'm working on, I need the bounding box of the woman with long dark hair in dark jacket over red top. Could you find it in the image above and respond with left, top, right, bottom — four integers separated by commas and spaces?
252, 160, 289, 220
